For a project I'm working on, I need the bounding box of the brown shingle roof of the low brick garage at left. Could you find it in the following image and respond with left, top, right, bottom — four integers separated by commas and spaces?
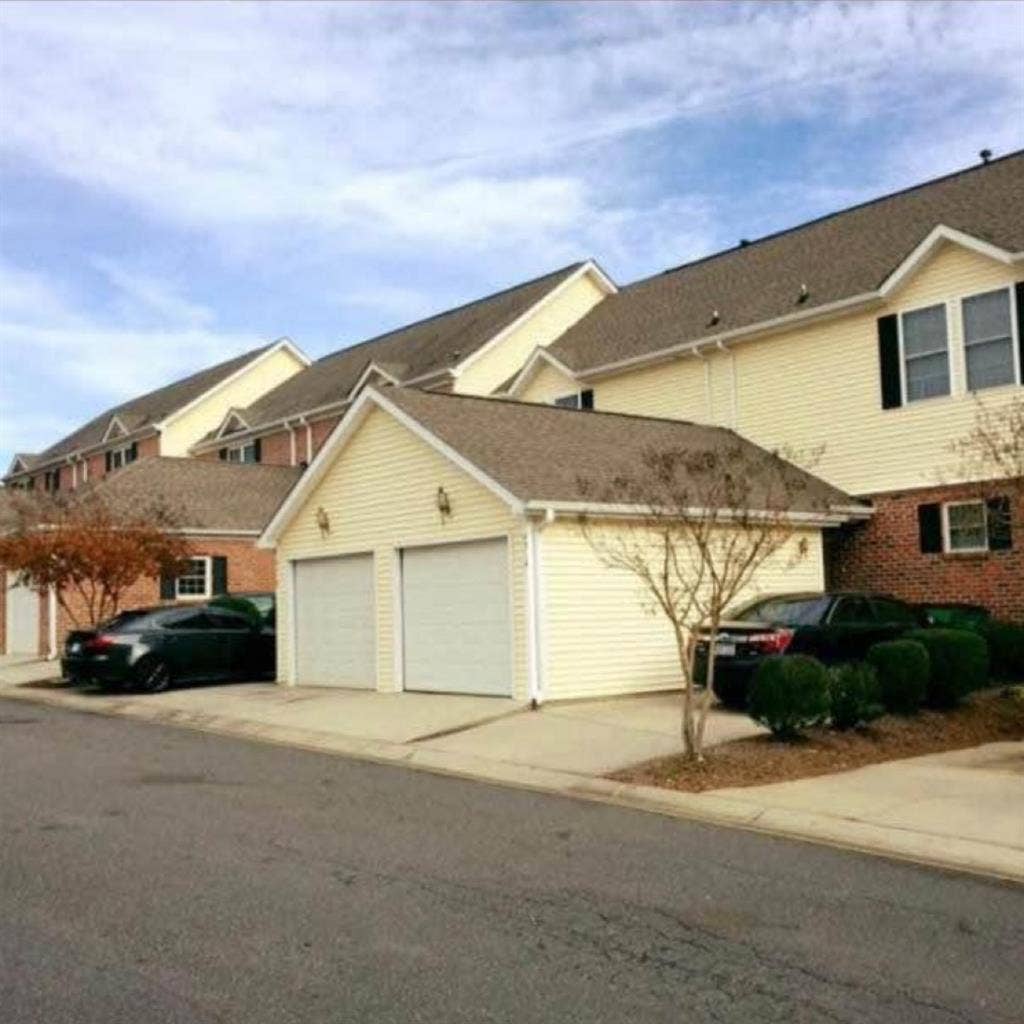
82, 457, 302, 532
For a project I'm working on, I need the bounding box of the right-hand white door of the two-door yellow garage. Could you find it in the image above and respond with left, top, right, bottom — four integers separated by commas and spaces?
401, 538, 512, 696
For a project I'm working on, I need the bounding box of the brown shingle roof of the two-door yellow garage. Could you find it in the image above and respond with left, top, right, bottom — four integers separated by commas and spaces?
380, 387, 861, 512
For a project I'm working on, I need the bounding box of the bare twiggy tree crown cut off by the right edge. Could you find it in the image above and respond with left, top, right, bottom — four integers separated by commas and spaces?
950, 395, 1024, 529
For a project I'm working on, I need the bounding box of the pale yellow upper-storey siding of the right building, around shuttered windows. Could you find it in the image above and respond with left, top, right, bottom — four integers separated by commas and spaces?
565, 243, 1022, 495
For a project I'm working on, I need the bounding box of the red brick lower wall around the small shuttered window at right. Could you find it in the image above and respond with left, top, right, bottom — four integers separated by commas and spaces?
826, 484, 1024, 622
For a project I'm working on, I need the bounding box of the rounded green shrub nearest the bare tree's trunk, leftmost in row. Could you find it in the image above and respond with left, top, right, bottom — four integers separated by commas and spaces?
750, 654, 828, 739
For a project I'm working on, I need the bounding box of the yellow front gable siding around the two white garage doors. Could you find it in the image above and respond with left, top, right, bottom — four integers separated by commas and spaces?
278, 409, 527, 699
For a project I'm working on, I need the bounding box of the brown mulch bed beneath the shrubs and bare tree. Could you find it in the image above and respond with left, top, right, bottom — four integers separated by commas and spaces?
610, 686, 1024, 793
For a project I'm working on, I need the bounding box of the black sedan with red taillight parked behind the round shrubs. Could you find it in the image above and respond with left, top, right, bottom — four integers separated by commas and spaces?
694, 593, 920, 710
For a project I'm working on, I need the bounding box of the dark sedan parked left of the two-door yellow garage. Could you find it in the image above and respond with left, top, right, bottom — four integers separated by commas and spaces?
60, 605, 274, 693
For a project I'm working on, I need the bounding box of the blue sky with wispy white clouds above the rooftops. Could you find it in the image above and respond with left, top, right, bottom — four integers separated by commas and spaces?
0, 0, 1024, 467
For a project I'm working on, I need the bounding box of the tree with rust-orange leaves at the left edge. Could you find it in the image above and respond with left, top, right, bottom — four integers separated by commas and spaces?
0, 486, 189, 628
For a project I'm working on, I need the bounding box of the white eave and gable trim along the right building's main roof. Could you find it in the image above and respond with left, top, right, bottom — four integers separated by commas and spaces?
575, 224, 1024, 380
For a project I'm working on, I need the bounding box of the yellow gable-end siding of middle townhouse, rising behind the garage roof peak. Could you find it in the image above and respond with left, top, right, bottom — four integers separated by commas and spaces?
453, 274, 604, 394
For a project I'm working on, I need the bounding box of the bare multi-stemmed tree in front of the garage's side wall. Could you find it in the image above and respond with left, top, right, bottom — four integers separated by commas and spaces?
579, 433, 826, 762
